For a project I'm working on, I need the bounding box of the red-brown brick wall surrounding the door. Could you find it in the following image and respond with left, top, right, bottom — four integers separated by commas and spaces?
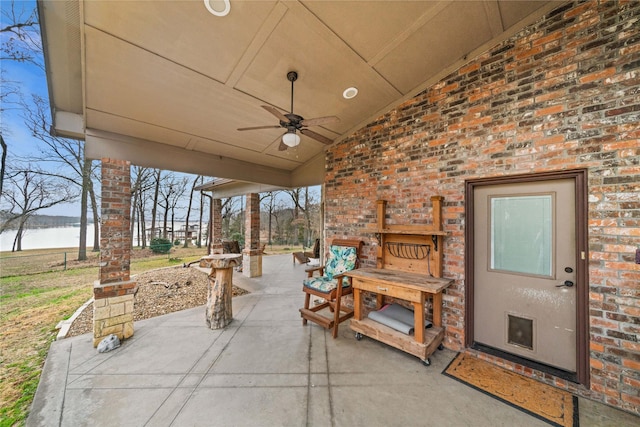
325, 1, 640, 413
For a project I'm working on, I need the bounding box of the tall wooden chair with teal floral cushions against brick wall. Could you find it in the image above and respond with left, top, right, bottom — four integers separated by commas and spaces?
300, 239, 363, 338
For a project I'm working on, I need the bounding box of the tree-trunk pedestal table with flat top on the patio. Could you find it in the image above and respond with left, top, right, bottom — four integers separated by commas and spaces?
200, 254, 242, 329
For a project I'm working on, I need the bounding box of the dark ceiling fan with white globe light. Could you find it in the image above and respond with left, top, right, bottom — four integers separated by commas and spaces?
238, 71, 340, 151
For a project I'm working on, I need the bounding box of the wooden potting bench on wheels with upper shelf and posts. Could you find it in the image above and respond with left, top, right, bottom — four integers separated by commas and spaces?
345, 196, 453, 365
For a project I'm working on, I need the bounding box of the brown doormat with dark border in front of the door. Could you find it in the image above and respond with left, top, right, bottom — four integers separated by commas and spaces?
442, 353, 579, 427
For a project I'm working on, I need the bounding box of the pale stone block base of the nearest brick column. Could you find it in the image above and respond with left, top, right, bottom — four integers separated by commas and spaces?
93, 280, 137, 347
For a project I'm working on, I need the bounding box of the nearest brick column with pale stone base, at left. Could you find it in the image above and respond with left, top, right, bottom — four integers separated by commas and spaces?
93, 158, 137, 347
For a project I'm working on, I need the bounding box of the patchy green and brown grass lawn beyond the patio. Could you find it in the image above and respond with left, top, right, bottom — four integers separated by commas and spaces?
0, 242, 302, 427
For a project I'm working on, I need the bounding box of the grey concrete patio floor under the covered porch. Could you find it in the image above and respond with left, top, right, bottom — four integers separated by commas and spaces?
27, 255, 640, 427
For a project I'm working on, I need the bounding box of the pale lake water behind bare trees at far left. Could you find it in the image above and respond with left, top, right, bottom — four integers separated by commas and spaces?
0, 224, 93, 251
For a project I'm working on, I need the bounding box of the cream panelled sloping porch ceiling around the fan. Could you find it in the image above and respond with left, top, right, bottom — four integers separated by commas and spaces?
38, 0, 559, 190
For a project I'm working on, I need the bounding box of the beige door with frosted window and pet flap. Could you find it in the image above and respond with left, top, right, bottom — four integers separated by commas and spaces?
473, 179, 577, 372
